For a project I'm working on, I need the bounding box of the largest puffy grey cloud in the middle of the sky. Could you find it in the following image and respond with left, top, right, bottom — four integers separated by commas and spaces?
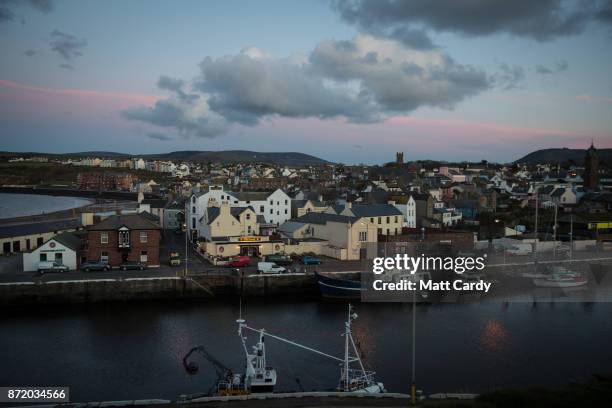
123, 35, 491, 137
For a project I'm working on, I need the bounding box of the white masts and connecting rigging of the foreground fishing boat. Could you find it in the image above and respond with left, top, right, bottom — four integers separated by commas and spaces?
236, 304, 385, 393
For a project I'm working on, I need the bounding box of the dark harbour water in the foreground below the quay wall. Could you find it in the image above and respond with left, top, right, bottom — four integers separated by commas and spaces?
0, 299, 612, 401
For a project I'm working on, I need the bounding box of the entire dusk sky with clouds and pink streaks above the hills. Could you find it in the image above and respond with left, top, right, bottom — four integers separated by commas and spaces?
0, 0, 612, 164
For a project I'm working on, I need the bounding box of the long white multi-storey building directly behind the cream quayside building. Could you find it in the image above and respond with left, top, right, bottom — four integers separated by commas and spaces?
187, 186, 291, 237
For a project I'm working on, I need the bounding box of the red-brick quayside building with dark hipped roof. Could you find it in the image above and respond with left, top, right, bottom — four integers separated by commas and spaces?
87, 214, 161, 266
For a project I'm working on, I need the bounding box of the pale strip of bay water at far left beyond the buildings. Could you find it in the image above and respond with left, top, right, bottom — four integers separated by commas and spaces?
0, 193, 92, 219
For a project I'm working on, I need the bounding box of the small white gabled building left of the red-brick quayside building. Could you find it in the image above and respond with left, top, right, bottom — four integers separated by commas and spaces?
23, 232, 82, 272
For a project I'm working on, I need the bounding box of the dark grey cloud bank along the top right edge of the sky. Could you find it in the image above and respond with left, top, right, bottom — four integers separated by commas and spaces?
332, 0, 612, 41
